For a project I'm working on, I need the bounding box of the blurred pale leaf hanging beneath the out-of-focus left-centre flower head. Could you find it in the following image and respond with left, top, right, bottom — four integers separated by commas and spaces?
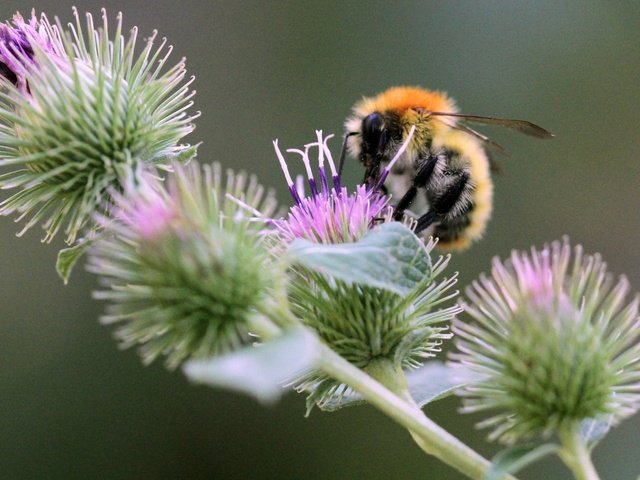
183, 327, 320, 404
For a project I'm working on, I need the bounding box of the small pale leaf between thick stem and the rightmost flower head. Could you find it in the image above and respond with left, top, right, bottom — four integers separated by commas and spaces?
406, 360, 471, 407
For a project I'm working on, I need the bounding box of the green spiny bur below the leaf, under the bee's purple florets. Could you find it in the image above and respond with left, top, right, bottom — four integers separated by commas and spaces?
289, 237, 460, 408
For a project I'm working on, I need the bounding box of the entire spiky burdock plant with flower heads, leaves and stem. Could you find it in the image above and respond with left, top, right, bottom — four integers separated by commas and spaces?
0, 6, 640, 480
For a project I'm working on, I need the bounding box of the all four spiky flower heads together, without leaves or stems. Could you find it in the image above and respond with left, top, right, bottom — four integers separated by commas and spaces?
5, 10, 640, 458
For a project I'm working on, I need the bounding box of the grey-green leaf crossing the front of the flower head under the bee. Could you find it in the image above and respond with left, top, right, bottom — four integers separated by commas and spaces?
288, 222, 431, 295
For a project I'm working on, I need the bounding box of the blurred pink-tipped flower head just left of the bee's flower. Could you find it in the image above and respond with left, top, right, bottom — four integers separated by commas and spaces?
89, 162, 277, 368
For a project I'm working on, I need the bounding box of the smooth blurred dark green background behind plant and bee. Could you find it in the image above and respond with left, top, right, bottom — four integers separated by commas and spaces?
0, 0, 640, 480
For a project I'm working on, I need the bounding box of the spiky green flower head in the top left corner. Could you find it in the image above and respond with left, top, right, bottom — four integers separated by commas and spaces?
0, 11, 195, 243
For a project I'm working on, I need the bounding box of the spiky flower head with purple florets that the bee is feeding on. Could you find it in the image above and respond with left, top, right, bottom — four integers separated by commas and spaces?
270, 131, 459, 408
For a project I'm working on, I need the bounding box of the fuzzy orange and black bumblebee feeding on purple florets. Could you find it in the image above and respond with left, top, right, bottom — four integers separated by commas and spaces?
340, 87, 553, 250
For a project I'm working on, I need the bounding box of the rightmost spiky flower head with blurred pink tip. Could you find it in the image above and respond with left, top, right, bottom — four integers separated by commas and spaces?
452, 239, 640, 443
